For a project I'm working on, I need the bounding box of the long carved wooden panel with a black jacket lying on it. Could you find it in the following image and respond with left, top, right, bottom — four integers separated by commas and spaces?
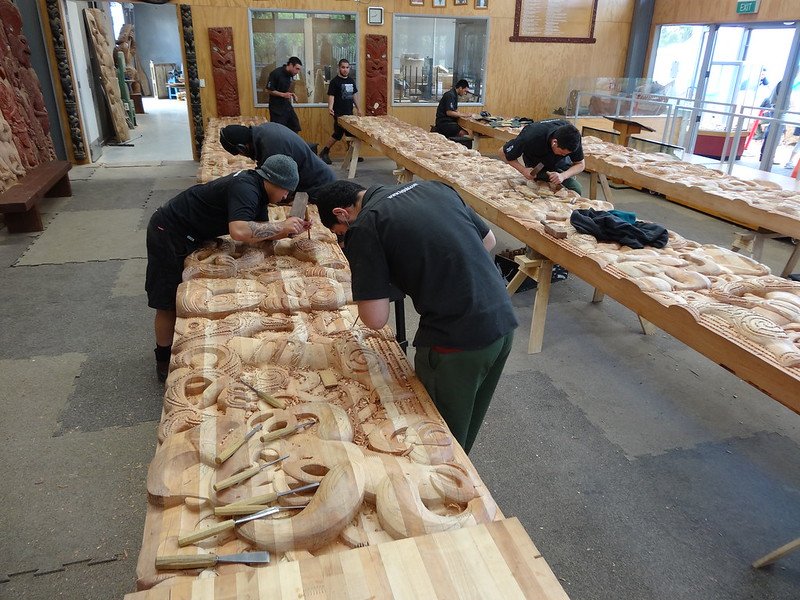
341, 117, 800, 412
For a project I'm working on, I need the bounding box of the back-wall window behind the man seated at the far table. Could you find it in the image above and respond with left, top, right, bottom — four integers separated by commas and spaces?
392, 15, 489, 104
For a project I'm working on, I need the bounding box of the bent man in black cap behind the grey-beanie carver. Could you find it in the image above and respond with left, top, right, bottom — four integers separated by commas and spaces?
219, 123, 336, 202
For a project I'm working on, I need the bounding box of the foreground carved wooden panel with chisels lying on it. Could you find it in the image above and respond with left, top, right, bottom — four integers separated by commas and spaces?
132, 206, 566, 599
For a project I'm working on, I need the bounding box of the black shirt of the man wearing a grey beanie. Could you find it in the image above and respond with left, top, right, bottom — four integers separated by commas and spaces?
161, 171, 269, 242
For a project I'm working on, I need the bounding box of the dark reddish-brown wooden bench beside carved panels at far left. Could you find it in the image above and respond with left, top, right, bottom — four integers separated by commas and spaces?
0, 160, 72, 233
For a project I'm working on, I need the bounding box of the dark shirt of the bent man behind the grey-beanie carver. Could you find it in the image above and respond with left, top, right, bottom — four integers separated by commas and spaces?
250, 123, 336, 192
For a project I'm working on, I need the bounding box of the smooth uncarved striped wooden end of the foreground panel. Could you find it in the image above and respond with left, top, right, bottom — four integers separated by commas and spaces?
125, 518, 568, 600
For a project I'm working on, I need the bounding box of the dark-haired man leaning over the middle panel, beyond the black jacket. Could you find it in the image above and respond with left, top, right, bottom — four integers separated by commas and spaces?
500, 119, 586, 195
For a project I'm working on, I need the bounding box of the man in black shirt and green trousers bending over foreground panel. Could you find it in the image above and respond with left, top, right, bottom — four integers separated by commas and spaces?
317, 180, 517, 452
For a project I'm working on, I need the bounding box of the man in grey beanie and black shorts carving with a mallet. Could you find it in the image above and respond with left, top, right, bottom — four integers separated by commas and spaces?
145, 154, 311, 381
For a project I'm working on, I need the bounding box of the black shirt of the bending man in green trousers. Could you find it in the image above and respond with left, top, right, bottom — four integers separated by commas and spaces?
345, 181, 517, 350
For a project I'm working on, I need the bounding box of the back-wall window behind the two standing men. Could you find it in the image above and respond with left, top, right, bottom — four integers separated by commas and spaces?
250, 10, 358, 106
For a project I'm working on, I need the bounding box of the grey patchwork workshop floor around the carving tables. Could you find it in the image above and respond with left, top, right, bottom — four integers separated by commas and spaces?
0, 149, 800, 600
